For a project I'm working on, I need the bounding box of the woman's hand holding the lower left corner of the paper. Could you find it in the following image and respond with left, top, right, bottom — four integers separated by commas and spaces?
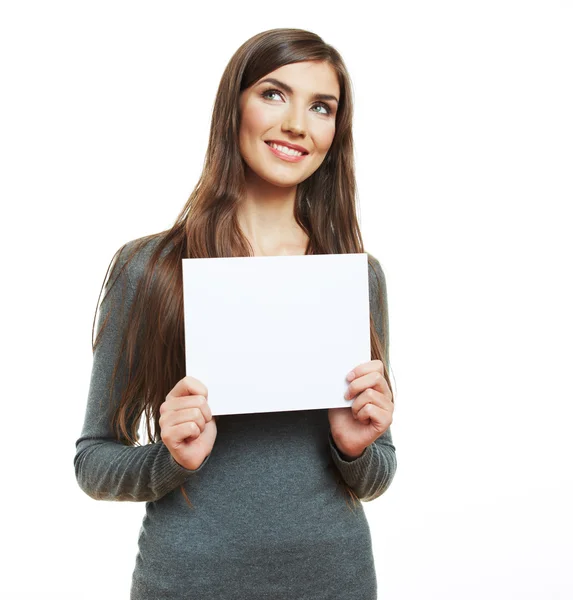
159, 376, 217, 471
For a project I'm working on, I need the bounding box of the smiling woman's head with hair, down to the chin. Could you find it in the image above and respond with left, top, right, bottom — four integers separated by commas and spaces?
201, 29, 353, 210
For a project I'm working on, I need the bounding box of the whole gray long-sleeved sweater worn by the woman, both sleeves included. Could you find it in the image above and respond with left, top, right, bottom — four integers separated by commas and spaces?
74, 240, 396, 600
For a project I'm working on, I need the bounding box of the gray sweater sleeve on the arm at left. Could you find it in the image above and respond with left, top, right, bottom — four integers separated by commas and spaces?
74, 242, 210, 502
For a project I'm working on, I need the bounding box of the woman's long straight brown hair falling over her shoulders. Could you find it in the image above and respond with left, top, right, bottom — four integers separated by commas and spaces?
92, 29, 392, 505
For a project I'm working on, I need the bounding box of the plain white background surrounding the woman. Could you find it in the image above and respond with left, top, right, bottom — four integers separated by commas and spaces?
0, 0, 573, 600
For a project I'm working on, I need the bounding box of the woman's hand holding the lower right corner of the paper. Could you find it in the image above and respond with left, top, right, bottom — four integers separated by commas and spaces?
328, 360, 394, 460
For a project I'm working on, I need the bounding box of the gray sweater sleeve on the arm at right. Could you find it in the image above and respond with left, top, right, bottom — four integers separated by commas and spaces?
328, 259, 397, 502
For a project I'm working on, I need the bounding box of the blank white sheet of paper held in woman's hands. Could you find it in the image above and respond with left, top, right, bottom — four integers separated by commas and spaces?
182, 253, 370, 416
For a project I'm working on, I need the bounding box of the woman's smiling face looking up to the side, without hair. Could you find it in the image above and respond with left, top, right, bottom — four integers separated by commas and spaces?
239, 61, 340, 187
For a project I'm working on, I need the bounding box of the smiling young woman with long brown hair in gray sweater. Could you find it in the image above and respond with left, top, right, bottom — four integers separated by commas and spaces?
74, 29, 396, 600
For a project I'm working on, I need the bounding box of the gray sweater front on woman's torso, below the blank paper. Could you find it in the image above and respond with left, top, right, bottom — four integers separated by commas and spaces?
131, 409, 376, 600
